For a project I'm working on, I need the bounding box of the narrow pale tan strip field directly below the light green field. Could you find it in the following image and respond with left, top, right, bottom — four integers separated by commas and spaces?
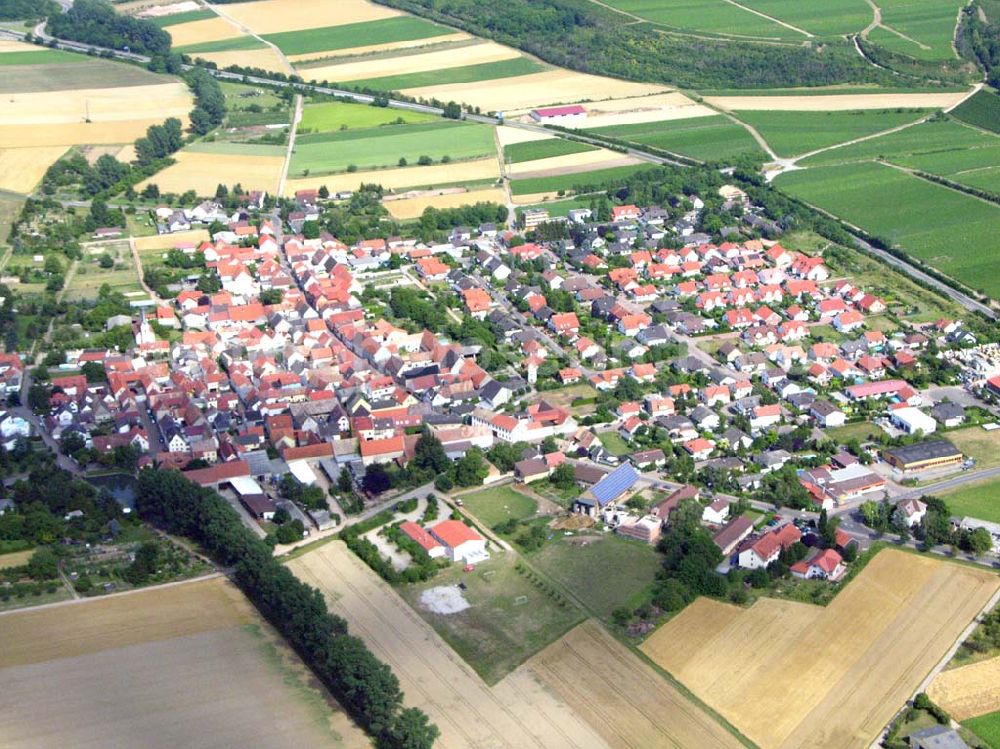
282, 158, 500, 195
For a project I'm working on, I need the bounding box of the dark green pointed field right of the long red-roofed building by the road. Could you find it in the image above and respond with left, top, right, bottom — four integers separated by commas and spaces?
591, 115, 764, 161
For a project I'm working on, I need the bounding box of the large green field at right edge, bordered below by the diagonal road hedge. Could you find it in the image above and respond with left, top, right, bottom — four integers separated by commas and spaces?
776, 163, 1000, 297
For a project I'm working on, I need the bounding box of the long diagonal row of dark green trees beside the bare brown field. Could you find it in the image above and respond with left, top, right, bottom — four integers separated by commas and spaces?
136, 468, 438, 749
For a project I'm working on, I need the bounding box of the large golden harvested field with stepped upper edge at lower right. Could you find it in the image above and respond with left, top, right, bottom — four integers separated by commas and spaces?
642, 550, 1000, 749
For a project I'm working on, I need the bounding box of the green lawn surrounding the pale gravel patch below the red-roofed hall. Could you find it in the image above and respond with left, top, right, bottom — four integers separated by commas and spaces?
399, 550, 584, 684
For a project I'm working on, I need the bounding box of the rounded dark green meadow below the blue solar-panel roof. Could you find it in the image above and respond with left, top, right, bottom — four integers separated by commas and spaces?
531, 533, 660, 619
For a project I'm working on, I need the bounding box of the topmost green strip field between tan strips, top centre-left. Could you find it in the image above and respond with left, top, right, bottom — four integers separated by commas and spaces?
263, 16, 452, 55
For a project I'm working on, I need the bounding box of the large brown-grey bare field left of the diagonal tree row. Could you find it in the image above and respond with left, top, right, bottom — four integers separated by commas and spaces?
0, 579, 368, 749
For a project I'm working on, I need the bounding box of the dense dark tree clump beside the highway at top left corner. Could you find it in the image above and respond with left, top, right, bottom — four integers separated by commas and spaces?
48, 0, 170, 55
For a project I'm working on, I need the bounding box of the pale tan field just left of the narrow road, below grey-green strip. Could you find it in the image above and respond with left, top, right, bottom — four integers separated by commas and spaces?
136, 151, 285, 195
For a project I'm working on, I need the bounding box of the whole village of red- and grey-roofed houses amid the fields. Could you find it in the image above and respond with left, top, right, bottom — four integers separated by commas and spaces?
0, 178, 1000, 612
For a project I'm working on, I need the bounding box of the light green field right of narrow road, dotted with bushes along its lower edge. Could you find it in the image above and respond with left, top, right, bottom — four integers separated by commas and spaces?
290, 119, 495, 175
